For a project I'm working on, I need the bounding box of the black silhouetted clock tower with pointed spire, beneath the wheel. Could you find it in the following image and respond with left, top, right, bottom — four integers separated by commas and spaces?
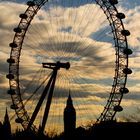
64, 94, 76, 137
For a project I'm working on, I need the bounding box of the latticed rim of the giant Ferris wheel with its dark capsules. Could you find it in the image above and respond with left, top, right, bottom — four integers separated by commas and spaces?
7, 0, 131, 131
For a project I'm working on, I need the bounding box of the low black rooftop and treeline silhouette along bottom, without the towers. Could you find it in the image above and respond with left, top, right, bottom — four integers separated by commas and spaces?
0, 122, 140, 140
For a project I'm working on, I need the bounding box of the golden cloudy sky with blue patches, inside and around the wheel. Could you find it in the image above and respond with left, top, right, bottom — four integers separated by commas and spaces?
0, 0, 140, 133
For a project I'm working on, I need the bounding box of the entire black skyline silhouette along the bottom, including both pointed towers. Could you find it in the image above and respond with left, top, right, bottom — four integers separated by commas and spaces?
0, 106, 140, 140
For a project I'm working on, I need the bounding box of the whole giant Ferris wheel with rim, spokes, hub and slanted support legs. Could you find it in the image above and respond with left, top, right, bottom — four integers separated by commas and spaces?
7, 0, 132, 134
